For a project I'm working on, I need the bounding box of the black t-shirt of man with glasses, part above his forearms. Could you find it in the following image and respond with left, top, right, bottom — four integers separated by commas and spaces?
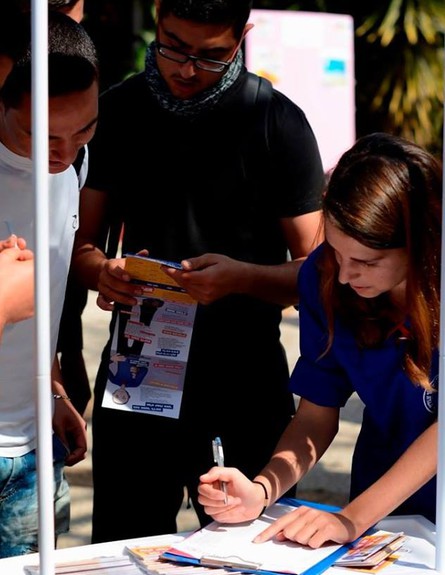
87, 67, 324, 263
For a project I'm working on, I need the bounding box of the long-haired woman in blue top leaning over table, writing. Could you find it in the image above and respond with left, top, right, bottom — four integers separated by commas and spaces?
199, 133, 442, 547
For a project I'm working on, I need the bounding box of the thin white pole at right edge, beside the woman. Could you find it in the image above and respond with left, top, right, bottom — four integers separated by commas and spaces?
436, 44, 445, 573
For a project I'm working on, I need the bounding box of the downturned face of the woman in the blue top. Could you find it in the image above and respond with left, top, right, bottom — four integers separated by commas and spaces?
325, 220, 408, 303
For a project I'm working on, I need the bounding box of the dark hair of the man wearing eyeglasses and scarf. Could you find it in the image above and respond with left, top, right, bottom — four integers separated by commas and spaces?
159, 0, 253, 39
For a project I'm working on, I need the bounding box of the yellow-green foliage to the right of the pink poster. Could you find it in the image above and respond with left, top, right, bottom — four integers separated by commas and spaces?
356, 0, 445, 153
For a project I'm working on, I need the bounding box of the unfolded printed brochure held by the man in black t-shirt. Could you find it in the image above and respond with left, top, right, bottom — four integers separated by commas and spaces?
102, 255, 197, 419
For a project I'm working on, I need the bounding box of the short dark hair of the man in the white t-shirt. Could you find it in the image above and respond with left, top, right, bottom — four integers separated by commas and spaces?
0, 12, 99, 108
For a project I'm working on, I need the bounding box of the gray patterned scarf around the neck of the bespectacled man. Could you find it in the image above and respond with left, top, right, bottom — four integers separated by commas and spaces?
145, 42, 243, 120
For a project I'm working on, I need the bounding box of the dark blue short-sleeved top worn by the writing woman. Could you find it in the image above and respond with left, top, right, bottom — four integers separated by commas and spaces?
290, 245, 439, 522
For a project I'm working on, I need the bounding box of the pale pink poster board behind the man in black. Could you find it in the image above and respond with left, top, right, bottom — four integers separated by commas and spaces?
245, 10, 356, 171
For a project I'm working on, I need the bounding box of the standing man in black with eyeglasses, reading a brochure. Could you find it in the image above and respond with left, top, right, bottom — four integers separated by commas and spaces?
74, 0, 324, 543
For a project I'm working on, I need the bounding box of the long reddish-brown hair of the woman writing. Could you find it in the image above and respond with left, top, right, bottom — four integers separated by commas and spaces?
320, 133, 442, 388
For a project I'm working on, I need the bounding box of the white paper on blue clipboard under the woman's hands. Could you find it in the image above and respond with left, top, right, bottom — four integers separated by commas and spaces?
164, 501, 348, 575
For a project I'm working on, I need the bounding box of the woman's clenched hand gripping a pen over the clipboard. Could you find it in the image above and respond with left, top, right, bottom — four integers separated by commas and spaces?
198, 467, 264, 523
